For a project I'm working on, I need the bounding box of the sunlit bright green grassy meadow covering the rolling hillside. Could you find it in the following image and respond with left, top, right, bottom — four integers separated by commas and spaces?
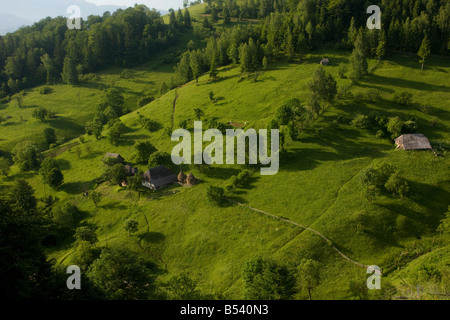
0, 38, 450, 299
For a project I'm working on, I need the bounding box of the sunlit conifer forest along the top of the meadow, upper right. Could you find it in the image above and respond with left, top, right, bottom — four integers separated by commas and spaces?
171, 0, 450, 83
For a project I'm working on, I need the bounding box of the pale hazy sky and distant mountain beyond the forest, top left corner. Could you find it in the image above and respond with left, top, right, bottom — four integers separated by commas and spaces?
0, 0, 168, 35
